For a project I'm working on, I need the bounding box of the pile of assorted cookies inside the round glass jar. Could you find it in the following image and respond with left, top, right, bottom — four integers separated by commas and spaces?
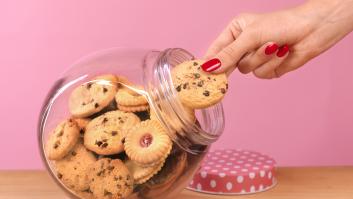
46, 74, 177, 198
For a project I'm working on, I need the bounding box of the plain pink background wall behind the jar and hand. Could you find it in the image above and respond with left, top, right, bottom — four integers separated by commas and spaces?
0, 0, 353, 169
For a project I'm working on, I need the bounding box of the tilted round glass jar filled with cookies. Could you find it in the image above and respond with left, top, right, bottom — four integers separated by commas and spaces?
38, 48, 224, 199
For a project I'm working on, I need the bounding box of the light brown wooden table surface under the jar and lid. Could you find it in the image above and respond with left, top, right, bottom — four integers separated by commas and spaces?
0, 167, 353, 199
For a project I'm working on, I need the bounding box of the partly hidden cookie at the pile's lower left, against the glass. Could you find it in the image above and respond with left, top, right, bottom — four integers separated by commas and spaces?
54, 142, 96, 191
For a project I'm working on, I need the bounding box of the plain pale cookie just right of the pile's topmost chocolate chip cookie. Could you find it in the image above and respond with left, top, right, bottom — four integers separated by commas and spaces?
115, 89, 148, 106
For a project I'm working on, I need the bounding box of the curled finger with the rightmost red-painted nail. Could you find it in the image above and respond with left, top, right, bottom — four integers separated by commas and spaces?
253, 45, 289, 79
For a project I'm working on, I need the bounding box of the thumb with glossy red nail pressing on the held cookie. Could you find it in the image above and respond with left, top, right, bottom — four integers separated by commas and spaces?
201, 32, 259, 73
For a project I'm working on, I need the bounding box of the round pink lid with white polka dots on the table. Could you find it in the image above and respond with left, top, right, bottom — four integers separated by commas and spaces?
188, 149, 277, 195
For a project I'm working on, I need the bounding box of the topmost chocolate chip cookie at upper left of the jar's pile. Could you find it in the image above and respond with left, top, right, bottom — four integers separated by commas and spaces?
69, 79, 117, 117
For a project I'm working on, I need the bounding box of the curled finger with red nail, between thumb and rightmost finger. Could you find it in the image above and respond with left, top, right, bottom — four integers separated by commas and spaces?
238, 42, 278, 74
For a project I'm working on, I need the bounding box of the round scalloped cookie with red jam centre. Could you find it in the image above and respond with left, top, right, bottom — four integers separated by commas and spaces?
124, 120, 172, 166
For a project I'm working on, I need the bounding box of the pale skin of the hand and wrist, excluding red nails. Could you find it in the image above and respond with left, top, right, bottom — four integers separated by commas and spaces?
205, 0, 353, 79
